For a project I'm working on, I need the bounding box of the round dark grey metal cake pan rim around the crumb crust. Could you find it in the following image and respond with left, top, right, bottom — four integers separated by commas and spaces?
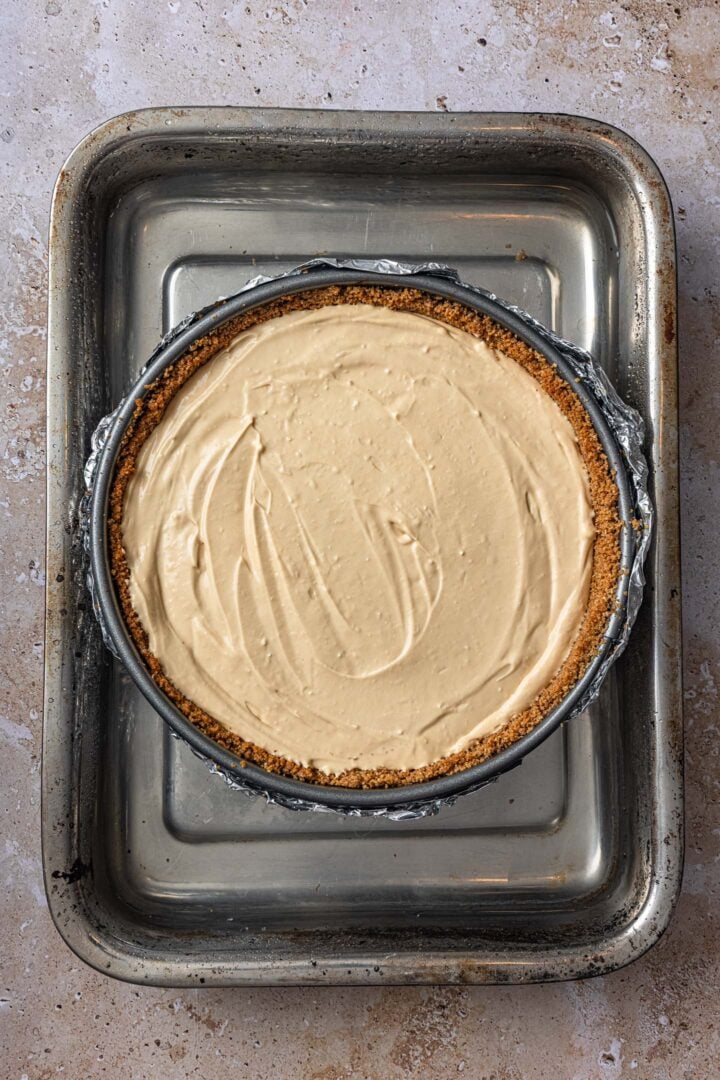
89, 267, 635, 818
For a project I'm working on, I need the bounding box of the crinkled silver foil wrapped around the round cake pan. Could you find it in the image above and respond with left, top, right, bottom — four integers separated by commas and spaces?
80, 258, 653, 821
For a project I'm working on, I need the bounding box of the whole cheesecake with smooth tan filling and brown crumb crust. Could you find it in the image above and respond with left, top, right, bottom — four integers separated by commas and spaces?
109, 285, 620, 787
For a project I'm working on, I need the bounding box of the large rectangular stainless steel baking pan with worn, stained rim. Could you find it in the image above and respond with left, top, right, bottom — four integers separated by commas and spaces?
43, 109, 682, 985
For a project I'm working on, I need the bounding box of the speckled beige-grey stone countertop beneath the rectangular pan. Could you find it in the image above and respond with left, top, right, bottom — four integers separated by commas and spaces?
0, 0, 720, 1080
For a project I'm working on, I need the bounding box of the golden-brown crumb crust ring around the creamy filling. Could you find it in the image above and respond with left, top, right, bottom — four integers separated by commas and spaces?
108, 285, 621, 788
